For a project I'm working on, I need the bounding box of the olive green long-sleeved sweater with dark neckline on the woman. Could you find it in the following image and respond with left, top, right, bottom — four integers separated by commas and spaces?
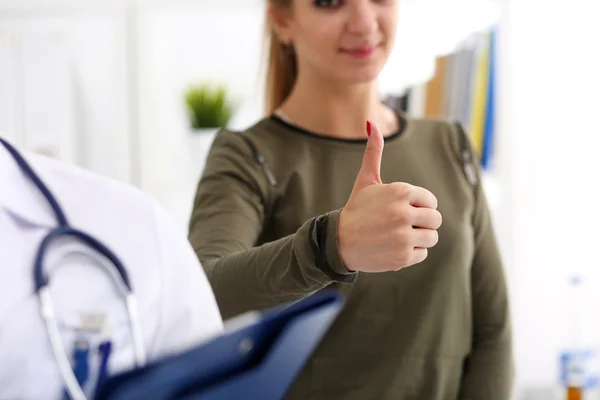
190, 117, 513, 400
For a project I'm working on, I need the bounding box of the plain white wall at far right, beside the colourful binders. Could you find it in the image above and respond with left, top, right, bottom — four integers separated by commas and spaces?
500, 0, 600, 398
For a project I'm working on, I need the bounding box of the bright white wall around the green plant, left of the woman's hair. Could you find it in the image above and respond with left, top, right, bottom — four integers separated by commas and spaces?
138, 3, 270, 226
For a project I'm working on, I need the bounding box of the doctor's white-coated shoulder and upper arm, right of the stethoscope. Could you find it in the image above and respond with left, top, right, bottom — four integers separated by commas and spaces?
29, 155, 223, 356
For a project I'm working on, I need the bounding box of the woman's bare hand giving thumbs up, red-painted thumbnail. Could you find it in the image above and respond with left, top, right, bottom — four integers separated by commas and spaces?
338, 122, 442, 272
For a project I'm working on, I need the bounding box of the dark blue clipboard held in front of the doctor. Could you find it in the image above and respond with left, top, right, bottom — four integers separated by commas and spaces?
95, 291, 343, 400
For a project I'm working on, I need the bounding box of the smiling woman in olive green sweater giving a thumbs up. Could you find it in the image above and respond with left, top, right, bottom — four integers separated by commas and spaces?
190, 0, 513, 400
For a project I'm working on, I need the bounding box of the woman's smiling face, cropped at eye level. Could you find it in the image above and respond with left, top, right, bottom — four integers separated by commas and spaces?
279, 0, 398, 84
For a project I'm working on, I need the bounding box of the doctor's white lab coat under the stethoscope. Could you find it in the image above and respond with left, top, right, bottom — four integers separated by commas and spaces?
0, 145, 223, 399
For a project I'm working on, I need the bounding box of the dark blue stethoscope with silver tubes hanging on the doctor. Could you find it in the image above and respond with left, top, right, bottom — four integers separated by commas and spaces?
0, 138, 146, 400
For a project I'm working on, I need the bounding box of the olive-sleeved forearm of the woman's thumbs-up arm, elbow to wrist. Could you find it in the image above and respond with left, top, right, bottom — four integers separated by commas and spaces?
197, 212, 356, 319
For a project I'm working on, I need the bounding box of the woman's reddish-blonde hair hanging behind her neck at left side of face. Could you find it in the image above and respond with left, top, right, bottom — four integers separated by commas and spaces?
265, 0, 298, 115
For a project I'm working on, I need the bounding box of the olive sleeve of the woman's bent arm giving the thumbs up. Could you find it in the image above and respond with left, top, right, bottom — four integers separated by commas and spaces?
189, 131, 356, 319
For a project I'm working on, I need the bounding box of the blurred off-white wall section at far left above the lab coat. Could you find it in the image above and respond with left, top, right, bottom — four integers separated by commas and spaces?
0, 10, 135, 181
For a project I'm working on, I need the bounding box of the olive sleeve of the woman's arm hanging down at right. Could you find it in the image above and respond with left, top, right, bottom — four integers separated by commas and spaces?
457, 123, 514, 400
